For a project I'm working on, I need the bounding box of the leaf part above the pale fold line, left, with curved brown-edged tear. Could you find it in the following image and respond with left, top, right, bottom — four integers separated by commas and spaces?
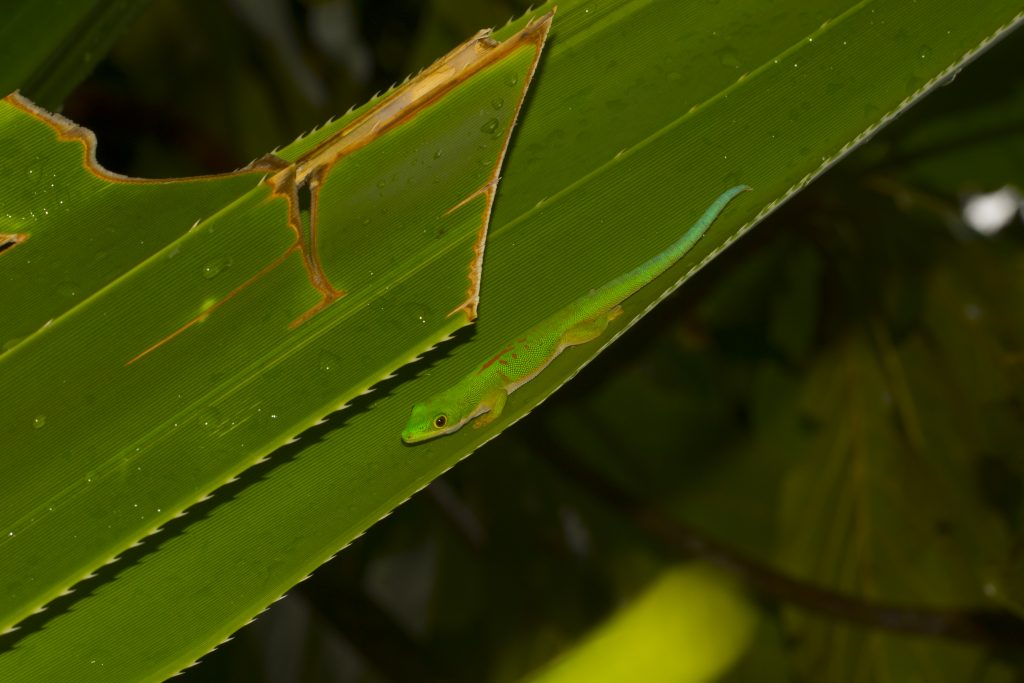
0, 93, 272, 347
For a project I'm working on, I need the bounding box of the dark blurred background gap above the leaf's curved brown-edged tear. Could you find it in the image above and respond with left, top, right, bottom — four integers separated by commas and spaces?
65, 0, 527, 177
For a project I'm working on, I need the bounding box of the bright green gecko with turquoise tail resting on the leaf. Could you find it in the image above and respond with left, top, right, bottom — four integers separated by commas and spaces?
401, 185, 750, 443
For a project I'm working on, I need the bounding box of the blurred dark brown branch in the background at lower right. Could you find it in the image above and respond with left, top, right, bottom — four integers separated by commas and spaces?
538, 444, 1024, 646
